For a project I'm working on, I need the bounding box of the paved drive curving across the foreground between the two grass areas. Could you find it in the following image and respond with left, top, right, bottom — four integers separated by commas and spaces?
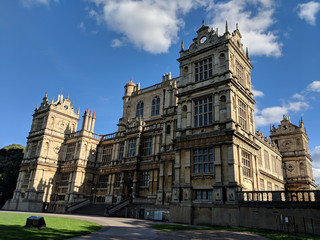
1, 211, 267, 240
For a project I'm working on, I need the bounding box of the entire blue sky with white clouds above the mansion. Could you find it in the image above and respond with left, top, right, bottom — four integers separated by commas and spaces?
0, 0, 320, 182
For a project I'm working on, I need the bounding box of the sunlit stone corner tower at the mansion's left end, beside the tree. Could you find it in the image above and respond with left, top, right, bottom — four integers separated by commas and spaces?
9, 94, 79, 211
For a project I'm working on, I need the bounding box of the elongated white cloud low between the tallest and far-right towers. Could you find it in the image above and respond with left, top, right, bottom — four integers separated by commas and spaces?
255, 101, 309, 127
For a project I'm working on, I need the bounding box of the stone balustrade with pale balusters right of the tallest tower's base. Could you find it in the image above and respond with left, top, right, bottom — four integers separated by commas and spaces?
237, 190, 320, 202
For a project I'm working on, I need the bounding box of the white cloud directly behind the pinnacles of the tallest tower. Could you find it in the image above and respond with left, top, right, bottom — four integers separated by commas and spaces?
207, 0, 282, 57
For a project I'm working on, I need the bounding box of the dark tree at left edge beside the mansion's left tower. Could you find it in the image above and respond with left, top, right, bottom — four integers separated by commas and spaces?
0, 144, 25, 208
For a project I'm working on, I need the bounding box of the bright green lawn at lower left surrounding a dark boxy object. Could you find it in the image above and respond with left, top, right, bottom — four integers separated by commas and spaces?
0, 212, 101, 240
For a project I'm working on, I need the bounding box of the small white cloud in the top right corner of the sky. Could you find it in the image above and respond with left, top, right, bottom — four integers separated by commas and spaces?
298, 1, 320, 25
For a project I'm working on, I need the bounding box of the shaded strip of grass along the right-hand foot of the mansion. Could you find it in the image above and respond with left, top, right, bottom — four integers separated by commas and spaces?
151, 224, 319, 240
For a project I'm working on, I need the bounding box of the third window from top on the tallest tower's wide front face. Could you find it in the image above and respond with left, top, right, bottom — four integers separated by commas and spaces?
193, 148, 213, 174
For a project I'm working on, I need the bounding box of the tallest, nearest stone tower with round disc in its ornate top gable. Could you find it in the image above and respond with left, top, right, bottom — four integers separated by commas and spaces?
172, 22, 255, 212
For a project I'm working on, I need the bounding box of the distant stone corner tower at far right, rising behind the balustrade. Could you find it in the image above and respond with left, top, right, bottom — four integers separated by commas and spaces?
270, 116, 315, 190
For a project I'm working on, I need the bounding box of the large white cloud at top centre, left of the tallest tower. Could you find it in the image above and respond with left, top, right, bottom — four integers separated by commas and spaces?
91, 0, 207, 54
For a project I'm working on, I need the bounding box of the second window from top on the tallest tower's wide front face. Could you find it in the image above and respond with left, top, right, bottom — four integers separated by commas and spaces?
194, 96, 213, 127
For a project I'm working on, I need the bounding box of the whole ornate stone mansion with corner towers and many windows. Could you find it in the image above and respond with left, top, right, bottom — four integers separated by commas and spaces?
4, 21, 315, 216
